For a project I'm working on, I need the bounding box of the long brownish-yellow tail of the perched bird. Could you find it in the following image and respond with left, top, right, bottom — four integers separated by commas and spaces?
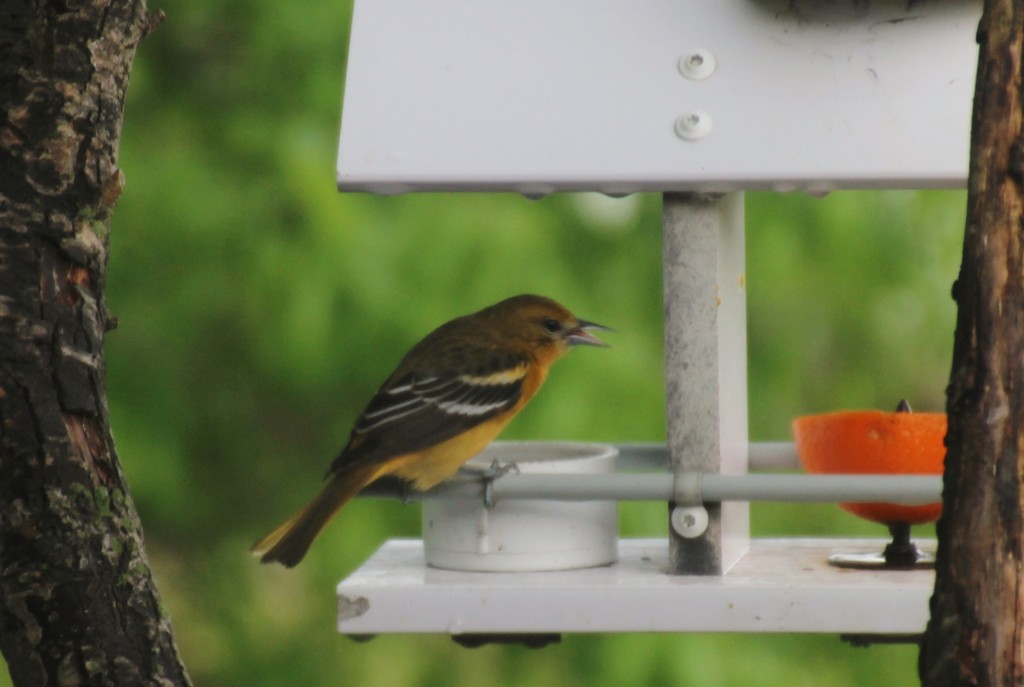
251, 469, 377, 567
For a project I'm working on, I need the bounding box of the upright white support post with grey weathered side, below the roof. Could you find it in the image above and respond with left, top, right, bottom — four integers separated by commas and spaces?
663, 192, 750, 574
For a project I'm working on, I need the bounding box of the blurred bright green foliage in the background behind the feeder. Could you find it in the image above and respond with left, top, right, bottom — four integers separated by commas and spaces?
0, 0, 965, 687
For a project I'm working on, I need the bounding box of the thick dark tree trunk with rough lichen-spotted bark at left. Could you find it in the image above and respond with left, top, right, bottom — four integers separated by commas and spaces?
0, 0, 188, 687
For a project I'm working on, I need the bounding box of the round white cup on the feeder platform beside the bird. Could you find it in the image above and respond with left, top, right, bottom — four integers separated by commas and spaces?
423, 441, 618, 572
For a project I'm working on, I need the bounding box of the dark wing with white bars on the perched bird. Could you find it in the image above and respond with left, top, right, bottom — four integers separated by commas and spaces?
329, 360, 527, 473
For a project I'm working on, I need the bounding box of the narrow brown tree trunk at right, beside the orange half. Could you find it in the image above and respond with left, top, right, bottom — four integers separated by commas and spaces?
920, 0, 1024, 687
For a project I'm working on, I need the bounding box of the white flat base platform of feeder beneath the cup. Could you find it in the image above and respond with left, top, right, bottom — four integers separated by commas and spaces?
338, 539, 935, 636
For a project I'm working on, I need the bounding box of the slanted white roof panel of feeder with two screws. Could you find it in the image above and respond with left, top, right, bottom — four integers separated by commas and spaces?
338, 0, 981, 195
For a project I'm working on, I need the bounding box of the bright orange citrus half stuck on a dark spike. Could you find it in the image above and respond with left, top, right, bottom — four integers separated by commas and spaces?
793, 411, 946, 525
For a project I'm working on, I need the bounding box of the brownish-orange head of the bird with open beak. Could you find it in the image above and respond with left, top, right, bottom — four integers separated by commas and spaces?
487, 295, 608, 357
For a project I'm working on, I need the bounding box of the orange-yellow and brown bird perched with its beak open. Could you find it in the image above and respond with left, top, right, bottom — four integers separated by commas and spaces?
252, 294, 608, 567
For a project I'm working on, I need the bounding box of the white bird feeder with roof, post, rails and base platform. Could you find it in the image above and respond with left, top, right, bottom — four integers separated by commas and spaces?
338, 0, 981, 643
